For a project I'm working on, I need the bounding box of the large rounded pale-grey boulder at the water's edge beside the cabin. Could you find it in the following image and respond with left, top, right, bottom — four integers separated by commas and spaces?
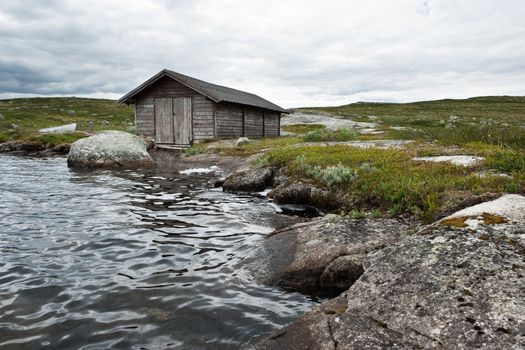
67, 131, 153, 168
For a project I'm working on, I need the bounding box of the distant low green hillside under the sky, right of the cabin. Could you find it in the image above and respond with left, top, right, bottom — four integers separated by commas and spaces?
301, 96, 525, 148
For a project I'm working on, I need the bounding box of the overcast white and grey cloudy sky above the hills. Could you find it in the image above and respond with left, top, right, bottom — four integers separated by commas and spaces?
0, 0, 525, 107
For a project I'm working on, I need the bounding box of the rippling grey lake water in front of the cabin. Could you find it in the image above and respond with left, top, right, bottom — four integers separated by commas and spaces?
0, 155, 314, 349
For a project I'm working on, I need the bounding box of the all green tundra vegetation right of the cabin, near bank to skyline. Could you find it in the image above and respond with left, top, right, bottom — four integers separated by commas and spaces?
233, 97, 525, 222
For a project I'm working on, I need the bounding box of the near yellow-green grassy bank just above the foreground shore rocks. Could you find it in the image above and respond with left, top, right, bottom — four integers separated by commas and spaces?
262, 145, 525, 221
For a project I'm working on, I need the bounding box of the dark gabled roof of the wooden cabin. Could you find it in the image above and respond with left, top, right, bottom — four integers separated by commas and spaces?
118, 69, 289, 113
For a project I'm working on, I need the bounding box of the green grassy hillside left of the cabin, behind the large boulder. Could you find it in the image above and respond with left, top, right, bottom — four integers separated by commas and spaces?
0, 97, 134, 142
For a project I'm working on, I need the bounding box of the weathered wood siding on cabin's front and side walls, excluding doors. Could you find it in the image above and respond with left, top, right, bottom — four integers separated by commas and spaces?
135, 77, 280, 141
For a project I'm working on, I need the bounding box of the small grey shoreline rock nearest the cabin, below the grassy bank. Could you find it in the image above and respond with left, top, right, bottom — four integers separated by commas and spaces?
222, 166, 273, 192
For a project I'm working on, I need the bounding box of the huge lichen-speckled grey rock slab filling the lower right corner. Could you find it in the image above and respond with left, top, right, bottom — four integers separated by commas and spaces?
254, 195, 525, 349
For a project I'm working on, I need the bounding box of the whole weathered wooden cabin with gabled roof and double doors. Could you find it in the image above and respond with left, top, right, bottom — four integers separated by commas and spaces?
118, 69, 288, 146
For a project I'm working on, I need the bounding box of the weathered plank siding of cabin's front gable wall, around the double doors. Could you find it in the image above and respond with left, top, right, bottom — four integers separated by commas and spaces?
135, 77, 216, 141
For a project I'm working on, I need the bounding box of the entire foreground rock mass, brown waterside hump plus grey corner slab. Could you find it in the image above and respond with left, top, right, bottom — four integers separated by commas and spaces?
248, 195, 525, 349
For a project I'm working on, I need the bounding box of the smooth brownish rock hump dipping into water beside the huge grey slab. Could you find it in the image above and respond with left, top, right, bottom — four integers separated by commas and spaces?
244, 215, 407, 294
